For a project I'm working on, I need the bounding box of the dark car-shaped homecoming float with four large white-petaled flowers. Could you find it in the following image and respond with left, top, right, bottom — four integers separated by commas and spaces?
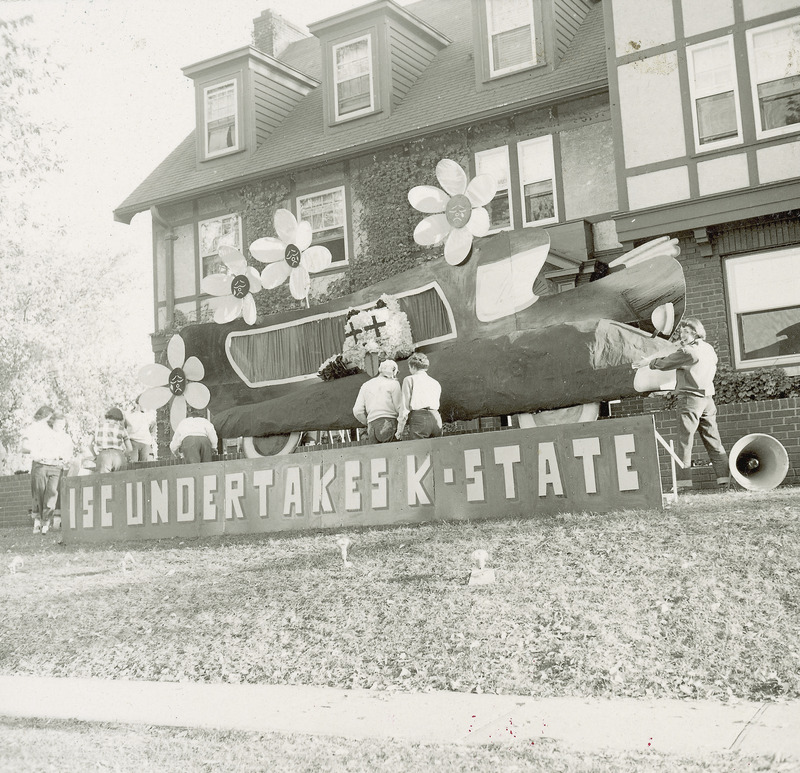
140, 160, 685, 455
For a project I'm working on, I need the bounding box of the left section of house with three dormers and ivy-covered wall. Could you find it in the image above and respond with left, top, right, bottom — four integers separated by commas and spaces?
114, 0, 620, 344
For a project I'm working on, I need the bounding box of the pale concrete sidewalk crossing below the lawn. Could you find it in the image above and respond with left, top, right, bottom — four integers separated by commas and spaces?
0, 676, 800, 759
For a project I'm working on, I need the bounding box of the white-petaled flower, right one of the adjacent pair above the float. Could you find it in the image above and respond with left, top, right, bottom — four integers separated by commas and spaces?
250, 209, 333, 300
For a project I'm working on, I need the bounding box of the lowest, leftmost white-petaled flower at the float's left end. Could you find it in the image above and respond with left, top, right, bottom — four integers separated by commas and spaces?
139, 334, 211, 429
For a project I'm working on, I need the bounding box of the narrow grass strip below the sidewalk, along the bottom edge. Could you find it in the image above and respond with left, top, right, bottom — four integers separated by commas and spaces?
0, 719, 796, 773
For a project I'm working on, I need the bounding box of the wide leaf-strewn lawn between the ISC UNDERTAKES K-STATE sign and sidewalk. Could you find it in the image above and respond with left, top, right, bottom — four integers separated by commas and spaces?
0, 489, 800, 700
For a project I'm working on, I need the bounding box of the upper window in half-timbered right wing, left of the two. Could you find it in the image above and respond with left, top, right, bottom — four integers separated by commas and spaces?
686, 36, 742, 151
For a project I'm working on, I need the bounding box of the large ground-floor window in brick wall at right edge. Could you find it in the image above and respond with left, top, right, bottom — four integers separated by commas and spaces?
725, 247, 800, 367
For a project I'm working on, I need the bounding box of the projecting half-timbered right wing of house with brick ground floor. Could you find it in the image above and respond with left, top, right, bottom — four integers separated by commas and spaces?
603, 0, 800, 374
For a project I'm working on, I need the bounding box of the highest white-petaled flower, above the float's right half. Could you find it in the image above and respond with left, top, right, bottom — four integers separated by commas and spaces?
408, 158, 497, 266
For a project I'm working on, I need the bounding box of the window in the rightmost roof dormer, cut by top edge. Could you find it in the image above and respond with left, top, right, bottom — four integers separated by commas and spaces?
486, 0, 536, 76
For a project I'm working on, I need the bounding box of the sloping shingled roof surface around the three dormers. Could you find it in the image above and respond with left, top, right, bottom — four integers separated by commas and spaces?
114, 0, 608, 222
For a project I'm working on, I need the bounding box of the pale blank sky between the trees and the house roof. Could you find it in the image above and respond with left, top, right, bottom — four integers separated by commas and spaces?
7, 0, 390, 350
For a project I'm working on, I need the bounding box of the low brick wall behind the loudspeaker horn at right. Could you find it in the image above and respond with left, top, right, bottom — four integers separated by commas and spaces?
611, 397, 800, 489
